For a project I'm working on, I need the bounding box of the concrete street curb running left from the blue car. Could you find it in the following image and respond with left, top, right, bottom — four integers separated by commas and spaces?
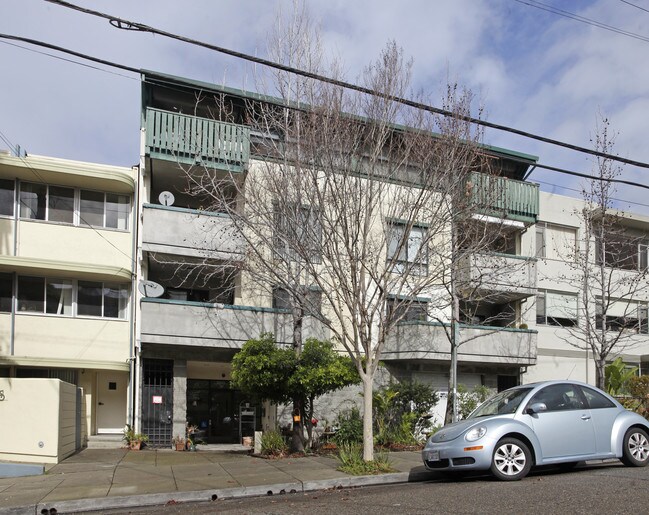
27, 472, 430, 515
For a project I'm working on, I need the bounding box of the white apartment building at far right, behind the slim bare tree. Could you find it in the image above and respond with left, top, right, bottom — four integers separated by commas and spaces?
522, 192, 649, 384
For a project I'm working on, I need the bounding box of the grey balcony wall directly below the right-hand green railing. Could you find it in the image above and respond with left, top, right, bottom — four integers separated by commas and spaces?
458, 254, 537, 302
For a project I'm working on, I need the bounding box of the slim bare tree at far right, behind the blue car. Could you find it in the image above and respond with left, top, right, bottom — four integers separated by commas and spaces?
565, 118, 649, 388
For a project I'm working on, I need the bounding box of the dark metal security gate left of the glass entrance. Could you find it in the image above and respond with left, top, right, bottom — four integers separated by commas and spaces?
142, 359, 174, 447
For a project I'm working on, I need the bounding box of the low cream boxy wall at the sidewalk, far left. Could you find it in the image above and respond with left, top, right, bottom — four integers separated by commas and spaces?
0, 378, 85, 463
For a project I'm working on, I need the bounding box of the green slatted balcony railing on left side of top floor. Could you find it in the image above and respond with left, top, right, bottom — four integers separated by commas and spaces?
146, 107, 250, 171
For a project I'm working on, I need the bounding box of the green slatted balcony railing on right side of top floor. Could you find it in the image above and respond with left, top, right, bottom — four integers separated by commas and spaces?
471, 172, 539, 224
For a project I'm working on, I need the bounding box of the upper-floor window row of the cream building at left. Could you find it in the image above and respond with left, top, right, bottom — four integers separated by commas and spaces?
18, 181, 131, 230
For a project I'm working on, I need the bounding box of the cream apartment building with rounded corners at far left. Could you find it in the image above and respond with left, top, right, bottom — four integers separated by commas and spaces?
0, 152, 137, 436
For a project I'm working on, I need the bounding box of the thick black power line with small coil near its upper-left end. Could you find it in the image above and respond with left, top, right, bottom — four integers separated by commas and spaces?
45, 0, 649, 173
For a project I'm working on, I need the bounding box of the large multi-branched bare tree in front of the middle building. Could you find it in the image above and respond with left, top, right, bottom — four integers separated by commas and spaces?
161, 3, 528, 461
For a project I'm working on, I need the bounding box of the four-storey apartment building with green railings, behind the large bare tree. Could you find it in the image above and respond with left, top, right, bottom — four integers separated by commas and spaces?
136, 72, 539, 445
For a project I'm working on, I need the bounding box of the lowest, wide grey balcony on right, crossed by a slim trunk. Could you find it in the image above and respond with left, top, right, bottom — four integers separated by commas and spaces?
381, 322, 538, 366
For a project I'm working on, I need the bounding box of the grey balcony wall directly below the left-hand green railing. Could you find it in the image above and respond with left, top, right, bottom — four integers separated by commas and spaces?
142, 204, 244, 259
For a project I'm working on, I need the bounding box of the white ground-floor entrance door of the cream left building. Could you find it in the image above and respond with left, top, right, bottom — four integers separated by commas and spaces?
95, 370, 128, 434
